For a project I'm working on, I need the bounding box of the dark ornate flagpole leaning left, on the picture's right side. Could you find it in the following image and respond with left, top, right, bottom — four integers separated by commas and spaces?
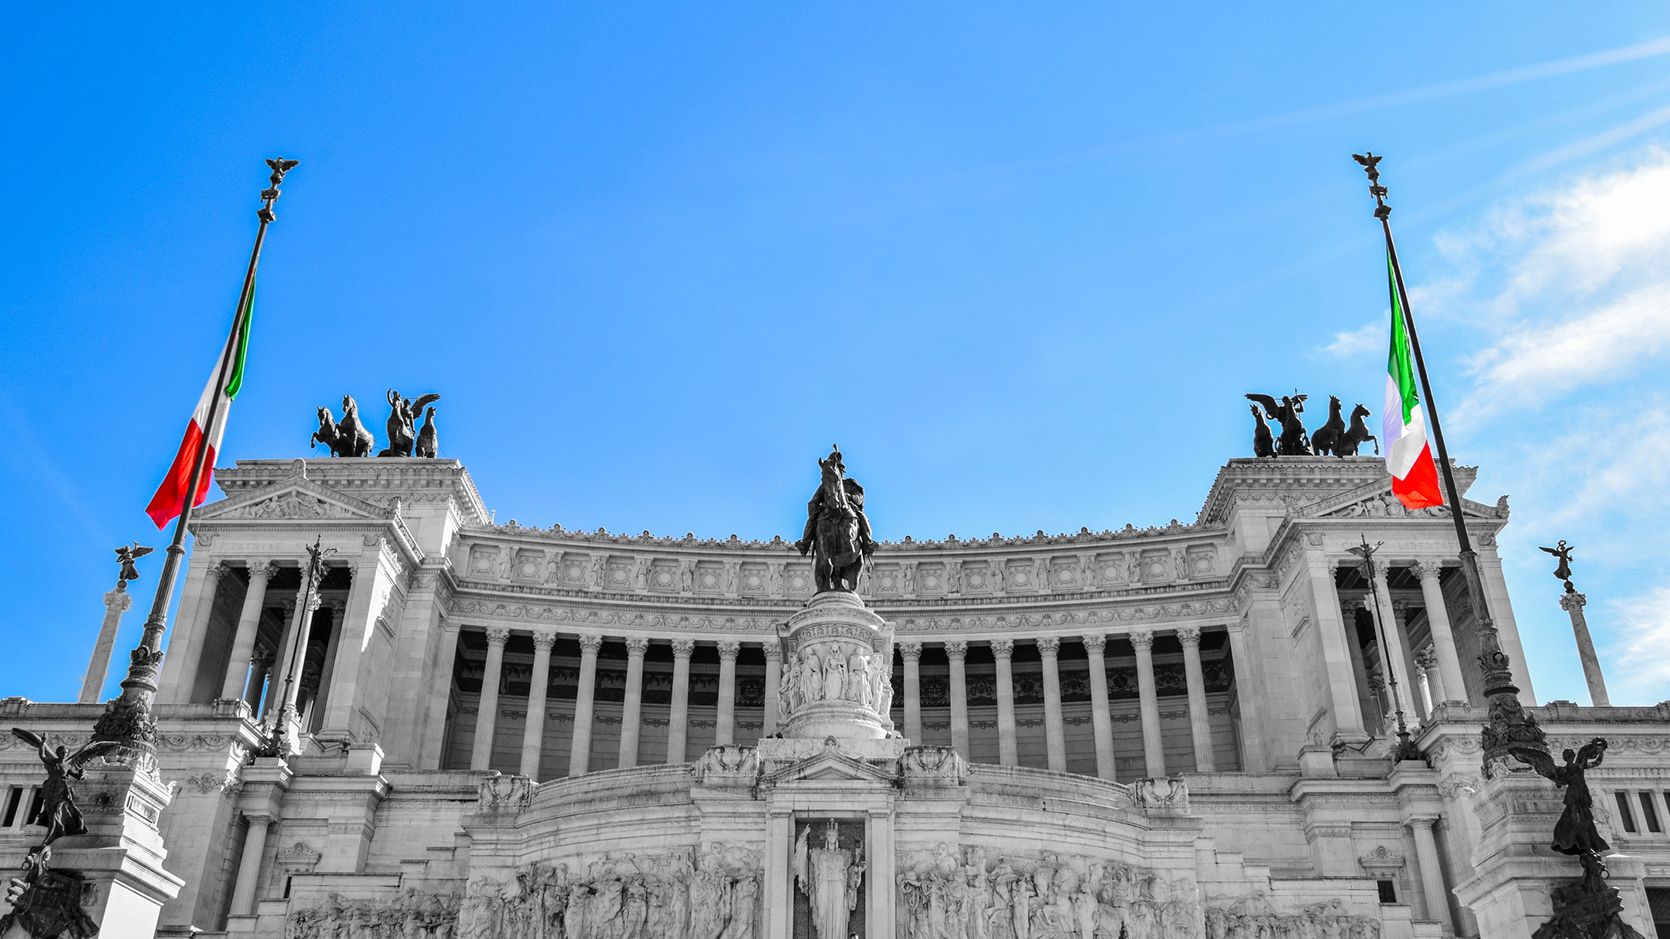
1354, 152, 1548, 774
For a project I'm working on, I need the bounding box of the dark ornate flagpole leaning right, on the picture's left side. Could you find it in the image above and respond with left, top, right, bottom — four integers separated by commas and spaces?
94, 157, 297, 772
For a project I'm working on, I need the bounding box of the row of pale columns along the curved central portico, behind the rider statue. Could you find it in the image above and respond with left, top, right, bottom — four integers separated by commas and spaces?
469, 623, 1256, 780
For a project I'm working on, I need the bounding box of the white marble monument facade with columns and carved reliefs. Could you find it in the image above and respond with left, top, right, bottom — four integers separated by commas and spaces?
0, 458, 1670, 939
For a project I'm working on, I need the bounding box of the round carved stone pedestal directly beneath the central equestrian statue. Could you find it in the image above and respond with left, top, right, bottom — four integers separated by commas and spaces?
780, 590, 895, 740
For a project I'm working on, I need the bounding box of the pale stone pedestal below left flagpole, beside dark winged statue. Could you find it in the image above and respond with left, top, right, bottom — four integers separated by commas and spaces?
29, 765, 185, 939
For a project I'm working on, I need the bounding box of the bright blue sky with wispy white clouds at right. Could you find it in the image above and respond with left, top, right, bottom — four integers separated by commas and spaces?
0, 3, 1670, 703
